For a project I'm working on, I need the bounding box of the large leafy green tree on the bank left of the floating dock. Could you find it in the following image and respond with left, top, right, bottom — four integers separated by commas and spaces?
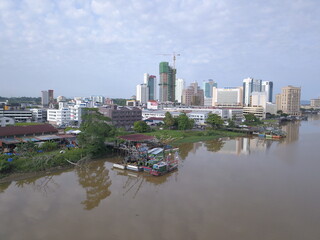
78, 109, 115, 156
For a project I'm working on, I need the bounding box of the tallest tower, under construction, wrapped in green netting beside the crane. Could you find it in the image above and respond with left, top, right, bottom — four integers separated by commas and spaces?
159, 62, 177, 102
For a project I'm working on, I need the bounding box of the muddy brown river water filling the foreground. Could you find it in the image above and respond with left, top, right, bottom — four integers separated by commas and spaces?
0, 117, 320, 240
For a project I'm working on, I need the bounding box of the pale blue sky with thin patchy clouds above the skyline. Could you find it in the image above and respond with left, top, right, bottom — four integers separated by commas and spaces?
0, 0, 320, 100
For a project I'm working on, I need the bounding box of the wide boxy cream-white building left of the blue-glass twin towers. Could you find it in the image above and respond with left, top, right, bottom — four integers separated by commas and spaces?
212, 87, 243, 107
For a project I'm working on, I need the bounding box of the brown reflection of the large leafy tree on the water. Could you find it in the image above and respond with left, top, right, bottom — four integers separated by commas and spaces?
76, 161, 111, 210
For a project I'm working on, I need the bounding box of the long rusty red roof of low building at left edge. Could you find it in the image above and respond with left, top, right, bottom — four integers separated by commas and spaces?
0, 124, 58, 137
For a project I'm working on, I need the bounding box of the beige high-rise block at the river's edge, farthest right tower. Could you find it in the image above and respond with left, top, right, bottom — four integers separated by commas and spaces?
281, 86, 301, 116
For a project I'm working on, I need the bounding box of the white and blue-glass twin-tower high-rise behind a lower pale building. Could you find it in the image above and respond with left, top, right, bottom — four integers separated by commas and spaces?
243, 78, 273, 106
